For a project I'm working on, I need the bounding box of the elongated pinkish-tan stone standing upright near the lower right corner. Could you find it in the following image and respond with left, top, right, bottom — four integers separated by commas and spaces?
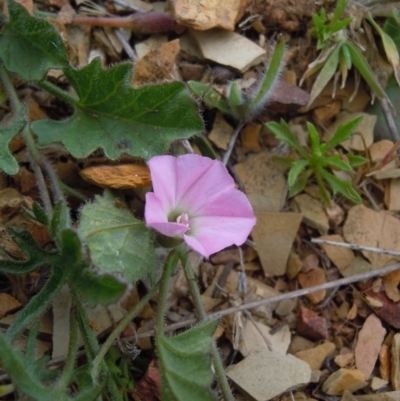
354, 314, 386, 380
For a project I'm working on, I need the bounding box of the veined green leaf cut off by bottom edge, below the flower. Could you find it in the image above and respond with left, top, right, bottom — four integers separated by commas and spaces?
156, 321, 217, 401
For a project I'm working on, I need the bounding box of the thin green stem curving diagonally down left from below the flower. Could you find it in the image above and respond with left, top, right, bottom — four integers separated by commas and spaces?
92, 283, 158, 382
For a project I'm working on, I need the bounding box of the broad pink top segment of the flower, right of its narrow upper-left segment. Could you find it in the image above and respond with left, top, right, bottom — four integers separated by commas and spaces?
176, 154, 235, 216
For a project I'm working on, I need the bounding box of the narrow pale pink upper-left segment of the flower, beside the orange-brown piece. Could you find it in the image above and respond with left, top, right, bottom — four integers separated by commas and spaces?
146, 156, 177, 214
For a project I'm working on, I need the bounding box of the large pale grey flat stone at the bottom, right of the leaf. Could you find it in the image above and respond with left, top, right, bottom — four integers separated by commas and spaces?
226, 350, 311, 401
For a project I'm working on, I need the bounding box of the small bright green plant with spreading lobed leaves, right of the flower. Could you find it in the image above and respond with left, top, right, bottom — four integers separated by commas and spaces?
266, 116, 365, 206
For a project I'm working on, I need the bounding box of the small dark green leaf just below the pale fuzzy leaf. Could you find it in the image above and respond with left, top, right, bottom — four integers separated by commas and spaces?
70, 270, 126, 306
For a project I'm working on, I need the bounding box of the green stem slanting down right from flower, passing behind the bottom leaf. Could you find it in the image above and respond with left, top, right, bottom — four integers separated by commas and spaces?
180, 247, 235, 401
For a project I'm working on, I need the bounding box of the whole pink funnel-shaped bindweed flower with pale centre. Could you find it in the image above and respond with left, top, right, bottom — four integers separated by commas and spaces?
145, 154, 256, 258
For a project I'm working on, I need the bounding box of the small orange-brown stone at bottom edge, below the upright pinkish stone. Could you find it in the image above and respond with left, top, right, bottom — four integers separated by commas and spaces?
322, 368, 368, 395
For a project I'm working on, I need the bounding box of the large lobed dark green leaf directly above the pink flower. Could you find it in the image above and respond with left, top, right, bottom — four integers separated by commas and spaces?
32, 58, 203, 159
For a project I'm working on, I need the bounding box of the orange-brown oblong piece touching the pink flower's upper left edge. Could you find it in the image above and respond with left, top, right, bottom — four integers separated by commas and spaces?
80, 163, 151, 189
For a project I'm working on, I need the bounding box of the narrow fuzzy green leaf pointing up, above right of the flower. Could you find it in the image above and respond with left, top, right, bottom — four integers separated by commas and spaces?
248, 41, 285, 113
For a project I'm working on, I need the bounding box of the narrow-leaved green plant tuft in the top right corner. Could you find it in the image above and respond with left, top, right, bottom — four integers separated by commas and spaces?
300, 0, 400, 105
